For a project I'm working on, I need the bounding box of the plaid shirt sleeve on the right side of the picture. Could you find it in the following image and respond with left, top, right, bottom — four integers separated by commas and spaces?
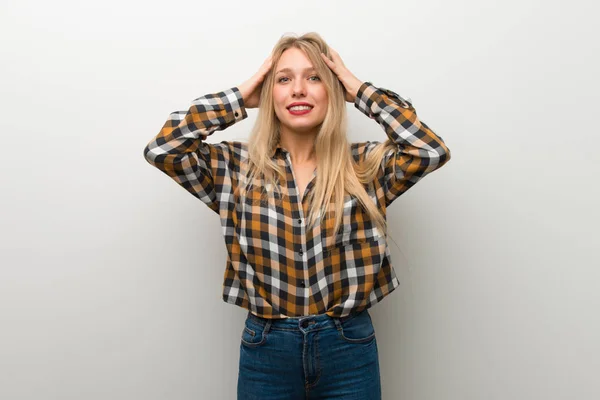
354, 82, 450, 206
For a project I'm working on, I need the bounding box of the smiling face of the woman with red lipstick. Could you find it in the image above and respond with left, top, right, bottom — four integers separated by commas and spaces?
273, 48, 328, 133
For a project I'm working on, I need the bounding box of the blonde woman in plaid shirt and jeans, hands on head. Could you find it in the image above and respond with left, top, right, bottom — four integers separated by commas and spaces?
144, 33, 450, 400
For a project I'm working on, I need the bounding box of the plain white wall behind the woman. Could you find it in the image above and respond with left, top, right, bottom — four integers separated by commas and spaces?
0, 0, 600, 400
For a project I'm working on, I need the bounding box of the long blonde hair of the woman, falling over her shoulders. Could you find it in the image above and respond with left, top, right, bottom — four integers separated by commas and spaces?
238, 32, 395, 241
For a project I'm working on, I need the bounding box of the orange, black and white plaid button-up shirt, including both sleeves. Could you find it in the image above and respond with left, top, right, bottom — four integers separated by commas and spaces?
144, 82, 450, 318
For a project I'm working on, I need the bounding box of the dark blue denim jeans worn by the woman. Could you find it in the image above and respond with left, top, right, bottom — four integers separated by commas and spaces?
237, 309, 381, 400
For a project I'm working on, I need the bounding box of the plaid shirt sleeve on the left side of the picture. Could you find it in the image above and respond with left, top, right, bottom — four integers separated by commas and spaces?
144, 87, 248, 213
